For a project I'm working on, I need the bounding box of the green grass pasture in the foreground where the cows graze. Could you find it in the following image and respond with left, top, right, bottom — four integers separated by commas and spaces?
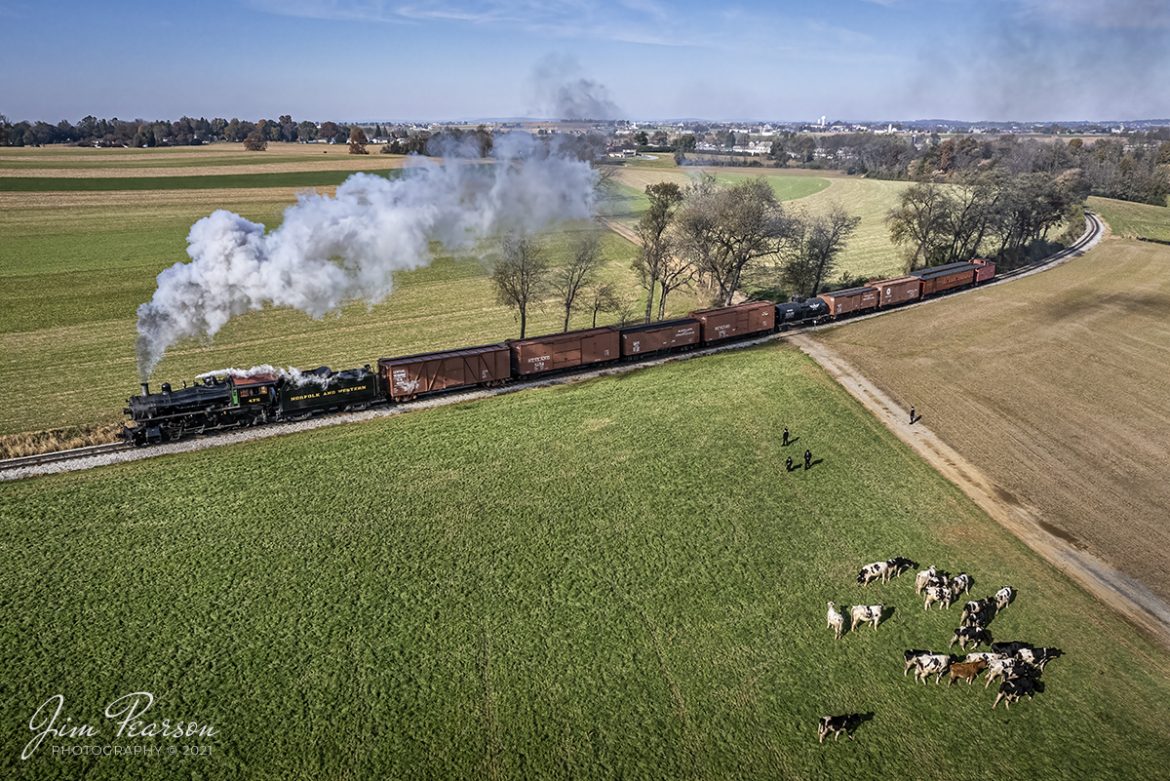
0, 345, 1170, 781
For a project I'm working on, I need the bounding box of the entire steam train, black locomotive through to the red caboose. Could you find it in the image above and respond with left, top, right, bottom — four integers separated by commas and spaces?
124, 260, 996, 445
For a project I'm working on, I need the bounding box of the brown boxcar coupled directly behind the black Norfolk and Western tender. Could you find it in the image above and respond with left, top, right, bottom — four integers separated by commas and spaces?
378, 344, 511, 401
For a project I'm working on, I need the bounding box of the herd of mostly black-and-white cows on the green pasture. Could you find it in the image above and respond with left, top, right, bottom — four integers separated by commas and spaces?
819, 557, 1062, 742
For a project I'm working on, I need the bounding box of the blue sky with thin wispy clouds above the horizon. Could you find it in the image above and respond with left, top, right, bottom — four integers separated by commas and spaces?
0, 0, 1170, 122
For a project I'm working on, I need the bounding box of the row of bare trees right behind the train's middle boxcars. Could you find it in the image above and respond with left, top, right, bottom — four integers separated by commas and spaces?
491, 175, 860, 338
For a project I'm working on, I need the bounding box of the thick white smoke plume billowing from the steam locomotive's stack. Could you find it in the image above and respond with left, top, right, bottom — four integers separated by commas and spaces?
138, 133, 596, 380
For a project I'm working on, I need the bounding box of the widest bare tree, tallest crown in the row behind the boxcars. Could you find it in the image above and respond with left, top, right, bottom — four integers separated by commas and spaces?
676, 177, 789, 305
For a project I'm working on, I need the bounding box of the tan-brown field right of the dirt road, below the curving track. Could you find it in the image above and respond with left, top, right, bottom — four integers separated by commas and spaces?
818, 225, 1170, 600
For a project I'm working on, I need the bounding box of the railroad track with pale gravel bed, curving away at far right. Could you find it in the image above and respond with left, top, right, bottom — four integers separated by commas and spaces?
0, 213, 1103, 481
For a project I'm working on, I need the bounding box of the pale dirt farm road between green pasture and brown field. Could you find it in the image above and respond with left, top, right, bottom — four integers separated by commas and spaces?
789, 333, 1170, 648
